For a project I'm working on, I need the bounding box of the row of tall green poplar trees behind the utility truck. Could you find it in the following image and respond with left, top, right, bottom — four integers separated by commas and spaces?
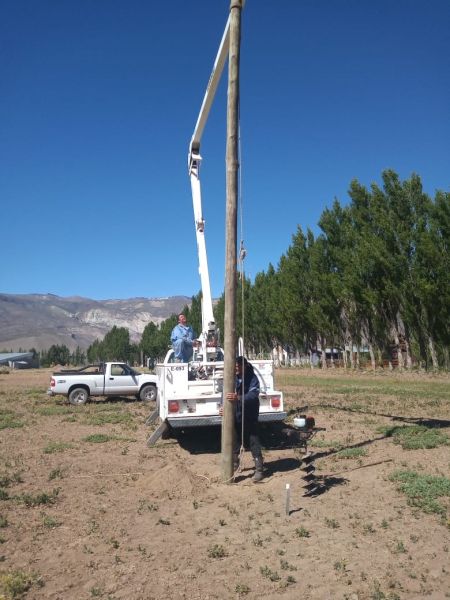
143, 170, 450, 369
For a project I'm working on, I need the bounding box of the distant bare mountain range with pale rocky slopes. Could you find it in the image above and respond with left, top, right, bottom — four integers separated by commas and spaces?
0, 294, 191, 352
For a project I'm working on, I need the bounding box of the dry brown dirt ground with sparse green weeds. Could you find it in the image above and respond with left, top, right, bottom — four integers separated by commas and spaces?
0, 370, 450, 600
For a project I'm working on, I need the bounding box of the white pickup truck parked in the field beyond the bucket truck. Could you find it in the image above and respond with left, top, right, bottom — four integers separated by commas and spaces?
47, 362, 158, 404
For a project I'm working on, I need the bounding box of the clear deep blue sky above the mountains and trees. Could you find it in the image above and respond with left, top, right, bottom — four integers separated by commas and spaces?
0, 0, 450, 299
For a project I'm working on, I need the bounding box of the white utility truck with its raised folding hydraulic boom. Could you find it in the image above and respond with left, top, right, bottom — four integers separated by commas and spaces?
147, 5, 286, 445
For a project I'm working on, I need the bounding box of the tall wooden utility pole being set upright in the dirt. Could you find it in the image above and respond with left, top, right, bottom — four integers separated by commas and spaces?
222, 0, 242, 482
